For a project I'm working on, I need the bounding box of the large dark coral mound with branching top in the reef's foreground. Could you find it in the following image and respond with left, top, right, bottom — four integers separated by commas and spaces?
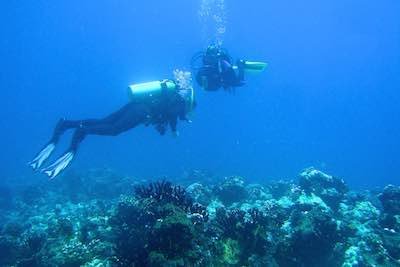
113, 181, 208, 266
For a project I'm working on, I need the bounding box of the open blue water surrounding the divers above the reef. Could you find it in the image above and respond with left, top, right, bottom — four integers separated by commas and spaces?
0, 0, 400, 187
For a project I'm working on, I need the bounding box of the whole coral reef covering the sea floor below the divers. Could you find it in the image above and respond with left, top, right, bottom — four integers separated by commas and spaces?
0, 168, 400, 267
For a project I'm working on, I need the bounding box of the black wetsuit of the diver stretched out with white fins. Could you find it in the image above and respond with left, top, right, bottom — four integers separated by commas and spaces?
50, 88, 186, 153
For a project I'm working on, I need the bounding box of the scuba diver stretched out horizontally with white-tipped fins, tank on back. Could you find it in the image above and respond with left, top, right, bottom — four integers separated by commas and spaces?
29, 70, 195, 179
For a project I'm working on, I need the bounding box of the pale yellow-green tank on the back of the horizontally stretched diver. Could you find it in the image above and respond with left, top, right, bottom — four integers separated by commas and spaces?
128, 80, 176, 98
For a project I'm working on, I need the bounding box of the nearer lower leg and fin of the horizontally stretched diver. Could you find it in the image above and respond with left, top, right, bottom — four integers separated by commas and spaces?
43, 105, 146, 179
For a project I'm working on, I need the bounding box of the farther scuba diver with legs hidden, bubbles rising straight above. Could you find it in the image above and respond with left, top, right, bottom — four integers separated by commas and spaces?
191, 45, 267, 91
